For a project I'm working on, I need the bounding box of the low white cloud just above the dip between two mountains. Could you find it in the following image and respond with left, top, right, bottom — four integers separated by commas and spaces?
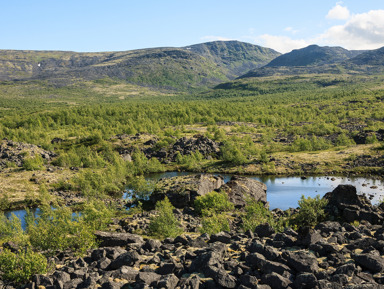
259, 34, 313, 53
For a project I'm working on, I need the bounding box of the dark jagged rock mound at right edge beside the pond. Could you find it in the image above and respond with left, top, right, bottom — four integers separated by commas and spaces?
324, 185, 384, 224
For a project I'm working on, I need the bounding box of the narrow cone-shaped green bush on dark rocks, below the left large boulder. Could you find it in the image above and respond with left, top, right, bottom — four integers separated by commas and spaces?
149, 197, 183, 238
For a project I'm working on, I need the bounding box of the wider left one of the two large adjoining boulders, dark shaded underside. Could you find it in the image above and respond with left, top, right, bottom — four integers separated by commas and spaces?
150, 174, 224, 208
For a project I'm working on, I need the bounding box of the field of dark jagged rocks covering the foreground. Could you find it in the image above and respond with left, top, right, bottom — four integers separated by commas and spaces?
15, 221, 384, 289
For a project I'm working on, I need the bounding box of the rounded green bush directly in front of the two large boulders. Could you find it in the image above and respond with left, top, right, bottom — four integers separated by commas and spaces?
195, 191, 235, 214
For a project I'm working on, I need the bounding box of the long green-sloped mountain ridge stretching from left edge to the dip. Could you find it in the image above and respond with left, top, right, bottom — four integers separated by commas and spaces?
0, 41, 280, 90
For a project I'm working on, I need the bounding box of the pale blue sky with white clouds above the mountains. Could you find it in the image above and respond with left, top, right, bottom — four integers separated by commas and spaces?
0, 0, 384, 53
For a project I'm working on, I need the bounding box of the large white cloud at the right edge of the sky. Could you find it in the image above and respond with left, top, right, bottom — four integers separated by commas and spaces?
321, 10, 384, 49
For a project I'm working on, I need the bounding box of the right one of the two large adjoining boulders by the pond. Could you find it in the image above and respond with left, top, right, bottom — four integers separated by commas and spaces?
221, 176, 267, 209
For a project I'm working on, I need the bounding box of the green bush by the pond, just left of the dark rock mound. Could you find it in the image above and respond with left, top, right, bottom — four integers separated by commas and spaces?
293, 195, 328, 226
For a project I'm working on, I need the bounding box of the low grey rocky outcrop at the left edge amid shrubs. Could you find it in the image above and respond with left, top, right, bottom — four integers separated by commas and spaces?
0, 139, 56, 167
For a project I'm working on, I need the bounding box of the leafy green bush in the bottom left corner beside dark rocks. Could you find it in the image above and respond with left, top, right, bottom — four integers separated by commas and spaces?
0, 249, 48, 284
